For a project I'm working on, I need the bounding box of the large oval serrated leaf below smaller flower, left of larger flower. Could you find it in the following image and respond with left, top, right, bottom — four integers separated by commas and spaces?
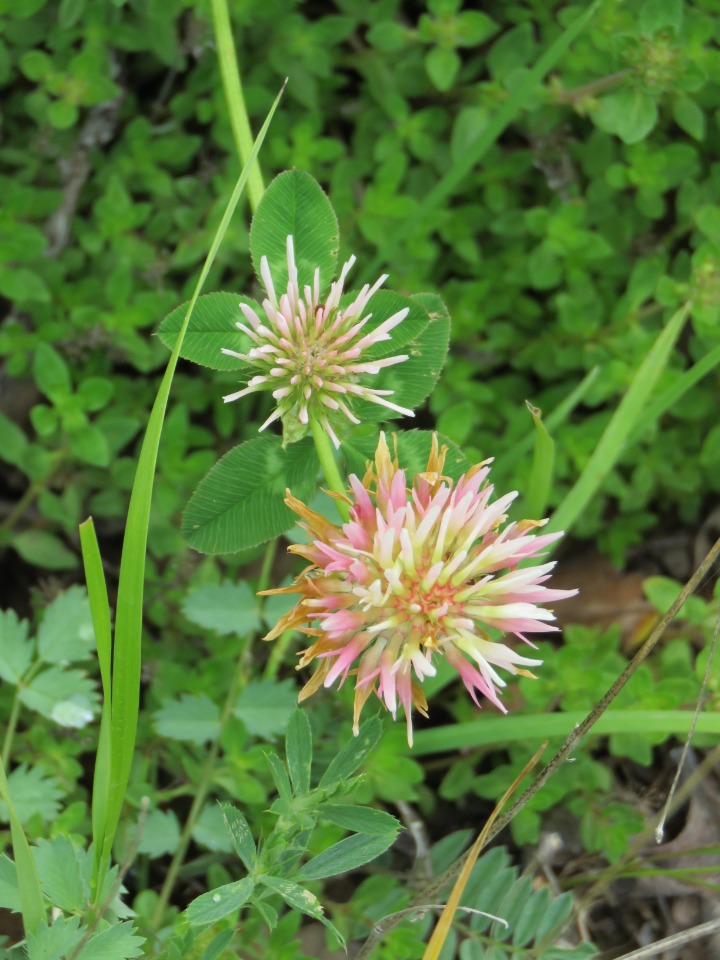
182, 436, 317, 554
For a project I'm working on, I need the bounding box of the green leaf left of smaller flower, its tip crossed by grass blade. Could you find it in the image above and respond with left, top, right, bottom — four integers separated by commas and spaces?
157, 292, 263, 371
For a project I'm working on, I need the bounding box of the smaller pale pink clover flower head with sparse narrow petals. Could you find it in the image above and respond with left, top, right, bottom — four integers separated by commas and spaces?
222, 236, 413, 447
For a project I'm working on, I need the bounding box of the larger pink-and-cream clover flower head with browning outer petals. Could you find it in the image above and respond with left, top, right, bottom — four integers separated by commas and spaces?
266, 434, 577, 745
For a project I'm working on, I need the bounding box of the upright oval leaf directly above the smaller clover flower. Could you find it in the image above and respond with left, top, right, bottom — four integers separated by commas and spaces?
250, 170, 340, 298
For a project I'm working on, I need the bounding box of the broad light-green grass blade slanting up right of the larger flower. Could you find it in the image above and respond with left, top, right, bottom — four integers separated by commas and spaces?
547, 304, 690, 531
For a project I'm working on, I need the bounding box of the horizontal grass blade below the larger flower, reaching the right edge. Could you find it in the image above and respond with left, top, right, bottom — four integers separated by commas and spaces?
408, 710, 720, 754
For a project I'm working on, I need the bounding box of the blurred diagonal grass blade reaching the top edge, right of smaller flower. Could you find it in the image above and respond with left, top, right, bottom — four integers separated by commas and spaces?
360, 0, 600, 278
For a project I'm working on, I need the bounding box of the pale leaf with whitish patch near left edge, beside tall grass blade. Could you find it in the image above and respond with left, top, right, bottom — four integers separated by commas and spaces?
20, 667, 100, 729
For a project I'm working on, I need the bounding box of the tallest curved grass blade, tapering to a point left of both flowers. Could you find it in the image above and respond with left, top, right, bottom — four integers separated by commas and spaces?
96, 86, 284, 884
